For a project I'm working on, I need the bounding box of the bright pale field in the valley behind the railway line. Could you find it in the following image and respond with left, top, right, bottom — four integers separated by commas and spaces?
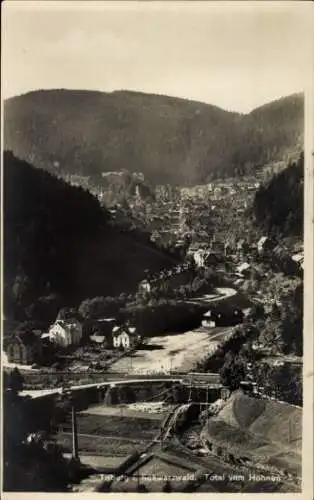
109, 327, 233, 374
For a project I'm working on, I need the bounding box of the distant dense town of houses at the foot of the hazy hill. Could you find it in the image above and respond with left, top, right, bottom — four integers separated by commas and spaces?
114, 179, 260, 254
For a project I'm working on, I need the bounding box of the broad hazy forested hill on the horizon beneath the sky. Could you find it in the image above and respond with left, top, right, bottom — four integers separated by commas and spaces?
4, 90, 303, 184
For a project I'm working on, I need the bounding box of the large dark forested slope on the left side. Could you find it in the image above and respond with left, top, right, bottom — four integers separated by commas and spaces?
4, 152, 177, 318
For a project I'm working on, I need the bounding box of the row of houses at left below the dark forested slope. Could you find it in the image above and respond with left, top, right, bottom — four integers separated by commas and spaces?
3, 317, 142, 365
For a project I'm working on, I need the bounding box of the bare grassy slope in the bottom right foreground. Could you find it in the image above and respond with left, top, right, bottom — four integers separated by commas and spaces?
202, 391, 302, 477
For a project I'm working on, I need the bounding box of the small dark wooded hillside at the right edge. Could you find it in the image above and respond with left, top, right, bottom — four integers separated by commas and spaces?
253, 154, 304, 239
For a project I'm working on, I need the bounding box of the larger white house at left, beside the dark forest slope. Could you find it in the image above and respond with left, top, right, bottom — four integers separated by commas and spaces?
49, 318, 83, 347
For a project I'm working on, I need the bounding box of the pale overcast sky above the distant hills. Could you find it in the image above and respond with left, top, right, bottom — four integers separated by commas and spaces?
2, 1, 313, 112
